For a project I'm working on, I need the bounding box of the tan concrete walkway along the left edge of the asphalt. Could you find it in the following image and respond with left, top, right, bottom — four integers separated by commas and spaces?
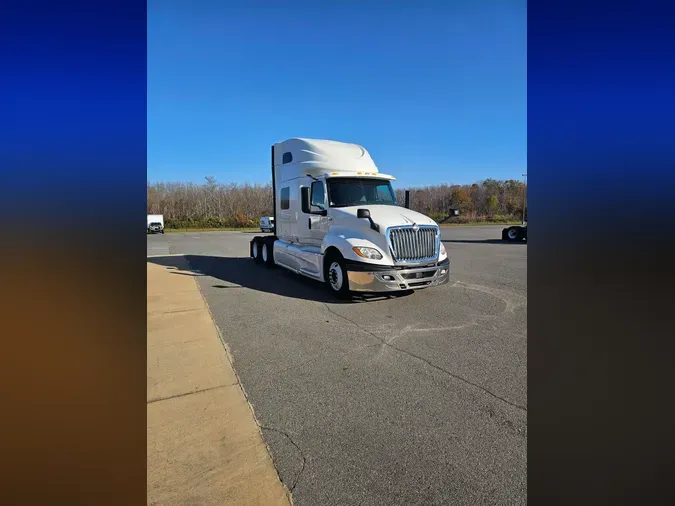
147, 255, 292, 506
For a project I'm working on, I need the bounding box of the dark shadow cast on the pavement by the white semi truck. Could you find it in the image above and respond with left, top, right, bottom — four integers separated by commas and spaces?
147, 255, 413, 304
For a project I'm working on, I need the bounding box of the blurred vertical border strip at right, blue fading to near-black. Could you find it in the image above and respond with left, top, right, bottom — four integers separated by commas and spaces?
528, 1, 675, 504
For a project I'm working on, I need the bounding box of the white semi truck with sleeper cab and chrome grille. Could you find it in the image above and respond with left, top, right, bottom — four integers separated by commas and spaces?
249, 138, 450, 298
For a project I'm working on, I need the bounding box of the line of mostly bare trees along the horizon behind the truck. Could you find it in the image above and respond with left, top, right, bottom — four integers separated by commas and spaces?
147, 177, 527, 228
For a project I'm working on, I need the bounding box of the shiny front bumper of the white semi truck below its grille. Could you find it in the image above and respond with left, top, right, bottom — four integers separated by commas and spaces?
346, 259, 450, 292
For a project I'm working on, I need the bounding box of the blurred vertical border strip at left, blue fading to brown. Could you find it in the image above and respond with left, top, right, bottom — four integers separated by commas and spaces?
0, 0, 147, 504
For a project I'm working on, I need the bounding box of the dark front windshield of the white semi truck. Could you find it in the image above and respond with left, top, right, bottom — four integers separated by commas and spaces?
327, 177, 396, 207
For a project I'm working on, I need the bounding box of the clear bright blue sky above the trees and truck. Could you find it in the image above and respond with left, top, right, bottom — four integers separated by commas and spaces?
148, 0, 527, 187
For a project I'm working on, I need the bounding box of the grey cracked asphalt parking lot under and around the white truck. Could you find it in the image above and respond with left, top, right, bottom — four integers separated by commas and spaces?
147, 226, 527, 506
